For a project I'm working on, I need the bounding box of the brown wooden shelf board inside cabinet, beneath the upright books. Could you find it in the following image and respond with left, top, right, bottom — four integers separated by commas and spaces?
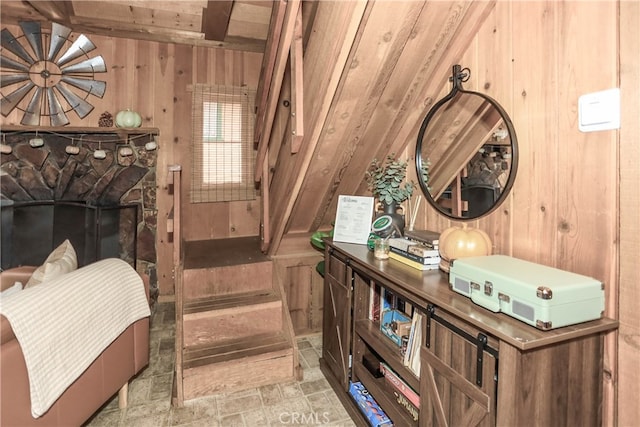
355, 320, 420, 391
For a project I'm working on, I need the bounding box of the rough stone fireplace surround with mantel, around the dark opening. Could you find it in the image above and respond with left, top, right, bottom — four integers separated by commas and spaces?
0, 126, 158, 302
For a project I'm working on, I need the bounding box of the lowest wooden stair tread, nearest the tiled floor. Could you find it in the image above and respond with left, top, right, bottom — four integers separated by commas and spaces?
183, 332, 293, 369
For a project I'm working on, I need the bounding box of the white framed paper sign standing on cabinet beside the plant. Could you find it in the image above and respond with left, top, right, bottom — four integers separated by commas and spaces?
333, 195, 373, 245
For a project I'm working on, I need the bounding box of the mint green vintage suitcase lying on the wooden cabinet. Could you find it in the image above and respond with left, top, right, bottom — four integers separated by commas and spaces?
449, 255, 604, 330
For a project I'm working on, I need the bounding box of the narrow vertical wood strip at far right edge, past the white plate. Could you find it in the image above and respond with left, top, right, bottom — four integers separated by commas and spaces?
616, 1, 640, 426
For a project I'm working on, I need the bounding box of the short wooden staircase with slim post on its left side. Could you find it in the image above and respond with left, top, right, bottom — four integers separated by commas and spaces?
172, 166, 302, 406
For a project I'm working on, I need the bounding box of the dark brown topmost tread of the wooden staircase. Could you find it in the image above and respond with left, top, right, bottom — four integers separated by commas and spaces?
183, 236, 271, 270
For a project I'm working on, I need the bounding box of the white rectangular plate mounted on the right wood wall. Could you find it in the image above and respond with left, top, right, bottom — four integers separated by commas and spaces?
578, 88, 620, 132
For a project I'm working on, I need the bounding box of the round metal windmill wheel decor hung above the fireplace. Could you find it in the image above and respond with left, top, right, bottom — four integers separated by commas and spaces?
0, 21, 107, 126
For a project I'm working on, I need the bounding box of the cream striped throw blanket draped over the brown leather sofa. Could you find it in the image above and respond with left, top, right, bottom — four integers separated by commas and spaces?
0, 258, 151, 418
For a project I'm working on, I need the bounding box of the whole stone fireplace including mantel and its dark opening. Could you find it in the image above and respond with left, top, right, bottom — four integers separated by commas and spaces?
0, 126, 159, 301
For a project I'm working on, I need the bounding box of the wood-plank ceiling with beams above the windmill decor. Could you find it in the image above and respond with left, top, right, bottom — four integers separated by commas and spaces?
0, 0, 272, 52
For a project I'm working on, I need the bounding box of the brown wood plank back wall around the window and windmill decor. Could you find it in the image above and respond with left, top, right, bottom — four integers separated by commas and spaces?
2, 26, 262, 298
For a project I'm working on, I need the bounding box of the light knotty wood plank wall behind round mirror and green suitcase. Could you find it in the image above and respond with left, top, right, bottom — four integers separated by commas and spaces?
410, 1, 640, 425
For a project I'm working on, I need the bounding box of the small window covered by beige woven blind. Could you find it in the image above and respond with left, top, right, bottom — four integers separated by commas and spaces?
191, 85, 256, 203
